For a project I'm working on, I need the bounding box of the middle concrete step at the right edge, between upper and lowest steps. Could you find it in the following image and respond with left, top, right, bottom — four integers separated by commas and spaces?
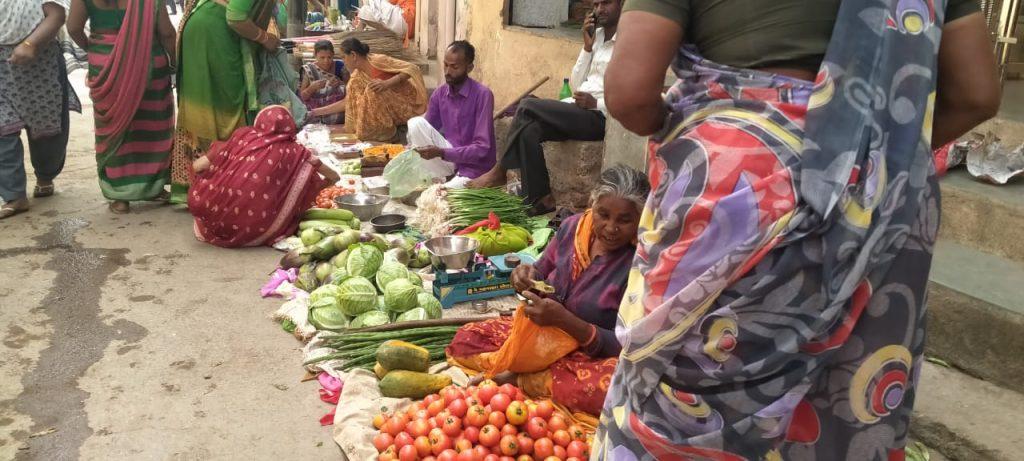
928, 240, 1024, 393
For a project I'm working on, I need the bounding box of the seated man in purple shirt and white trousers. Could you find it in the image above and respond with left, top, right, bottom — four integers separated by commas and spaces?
409, 40, 497, 179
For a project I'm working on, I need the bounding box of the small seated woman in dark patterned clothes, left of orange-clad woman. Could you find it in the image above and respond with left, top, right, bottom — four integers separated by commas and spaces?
299, 40, 349, 125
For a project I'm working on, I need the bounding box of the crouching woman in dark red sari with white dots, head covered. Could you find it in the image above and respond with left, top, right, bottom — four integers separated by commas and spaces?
188, 106, 338, 248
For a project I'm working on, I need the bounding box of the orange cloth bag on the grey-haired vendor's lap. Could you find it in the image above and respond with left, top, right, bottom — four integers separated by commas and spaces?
486, 305, 580, 378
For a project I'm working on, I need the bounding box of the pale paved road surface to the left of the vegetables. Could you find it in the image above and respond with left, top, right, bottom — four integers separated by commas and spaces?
0, 74, 339, 461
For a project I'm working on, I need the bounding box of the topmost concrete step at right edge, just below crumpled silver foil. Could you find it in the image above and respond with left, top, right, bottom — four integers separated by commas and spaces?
939, 169, 1024, 262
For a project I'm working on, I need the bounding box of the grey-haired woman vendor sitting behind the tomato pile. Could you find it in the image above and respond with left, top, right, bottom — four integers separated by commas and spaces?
447, 165, 650, 415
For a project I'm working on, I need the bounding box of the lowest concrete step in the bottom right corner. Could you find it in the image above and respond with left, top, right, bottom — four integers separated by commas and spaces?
910, 362, 1024, 461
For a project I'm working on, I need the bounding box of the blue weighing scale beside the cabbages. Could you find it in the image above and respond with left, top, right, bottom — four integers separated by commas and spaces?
433, 253, 535, 308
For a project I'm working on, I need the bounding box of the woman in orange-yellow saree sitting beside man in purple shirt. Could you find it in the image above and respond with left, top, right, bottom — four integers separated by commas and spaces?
310, 38, 427, 142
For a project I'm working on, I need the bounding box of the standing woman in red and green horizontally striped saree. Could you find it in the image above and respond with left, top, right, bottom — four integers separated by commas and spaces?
68, 0, 175, 213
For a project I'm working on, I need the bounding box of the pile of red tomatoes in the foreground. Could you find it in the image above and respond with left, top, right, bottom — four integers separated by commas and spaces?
374, 381, 590, 461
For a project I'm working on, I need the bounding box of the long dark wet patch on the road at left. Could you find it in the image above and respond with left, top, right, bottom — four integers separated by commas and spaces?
0, 218, 148, 460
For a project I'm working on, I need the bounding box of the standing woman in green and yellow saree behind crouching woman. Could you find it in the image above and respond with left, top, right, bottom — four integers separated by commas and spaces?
171, 0, 280, 203
